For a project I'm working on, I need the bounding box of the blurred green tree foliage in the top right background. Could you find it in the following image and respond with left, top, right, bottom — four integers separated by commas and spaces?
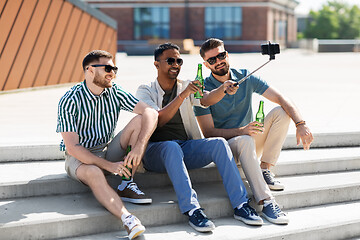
304, 0, 360, 39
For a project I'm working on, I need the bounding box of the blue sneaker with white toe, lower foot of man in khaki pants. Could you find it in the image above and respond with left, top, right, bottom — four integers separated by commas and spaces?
262, 199, 289, 224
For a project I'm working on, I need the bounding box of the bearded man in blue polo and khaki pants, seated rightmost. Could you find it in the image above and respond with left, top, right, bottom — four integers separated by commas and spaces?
195, 38, 313, 223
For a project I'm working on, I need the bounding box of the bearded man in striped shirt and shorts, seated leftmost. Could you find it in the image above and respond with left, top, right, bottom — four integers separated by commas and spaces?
56, 50, 158, 239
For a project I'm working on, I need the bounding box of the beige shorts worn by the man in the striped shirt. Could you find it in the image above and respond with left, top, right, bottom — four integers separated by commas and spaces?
65, 131, 126, 182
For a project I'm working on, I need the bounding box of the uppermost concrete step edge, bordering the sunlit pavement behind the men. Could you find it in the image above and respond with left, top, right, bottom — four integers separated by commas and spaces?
0, 132, 360, 163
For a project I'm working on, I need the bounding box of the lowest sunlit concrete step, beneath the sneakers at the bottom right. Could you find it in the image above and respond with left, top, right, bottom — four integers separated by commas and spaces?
64, 201, 360, 240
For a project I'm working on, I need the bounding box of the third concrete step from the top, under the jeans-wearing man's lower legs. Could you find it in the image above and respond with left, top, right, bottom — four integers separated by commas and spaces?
0, 171, 360, 239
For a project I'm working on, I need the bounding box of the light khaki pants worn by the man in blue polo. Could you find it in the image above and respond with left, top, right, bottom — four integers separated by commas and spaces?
228, 107, 290, 202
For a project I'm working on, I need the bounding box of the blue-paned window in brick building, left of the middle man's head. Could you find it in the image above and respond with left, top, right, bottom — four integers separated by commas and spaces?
134, 7, 170, 40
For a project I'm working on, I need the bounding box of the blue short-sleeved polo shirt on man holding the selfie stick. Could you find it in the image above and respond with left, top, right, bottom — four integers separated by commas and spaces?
194, 68, 269, 128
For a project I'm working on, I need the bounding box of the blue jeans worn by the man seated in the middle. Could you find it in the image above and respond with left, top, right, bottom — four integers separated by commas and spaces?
143, 138, 247, 213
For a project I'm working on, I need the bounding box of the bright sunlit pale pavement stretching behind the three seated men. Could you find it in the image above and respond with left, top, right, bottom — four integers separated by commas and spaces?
0, 49, 360, 146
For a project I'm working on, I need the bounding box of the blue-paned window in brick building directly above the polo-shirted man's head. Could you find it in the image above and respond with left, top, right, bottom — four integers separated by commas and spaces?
205, 7, 242, 40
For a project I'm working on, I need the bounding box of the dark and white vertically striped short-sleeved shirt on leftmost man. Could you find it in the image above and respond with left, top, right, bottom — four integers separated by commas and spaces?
56, 81, 139, 151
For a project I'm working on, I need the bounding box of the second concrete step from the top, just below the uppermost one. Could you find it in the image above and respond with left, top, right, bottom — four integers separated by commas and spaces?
0, 147, 360, 199
